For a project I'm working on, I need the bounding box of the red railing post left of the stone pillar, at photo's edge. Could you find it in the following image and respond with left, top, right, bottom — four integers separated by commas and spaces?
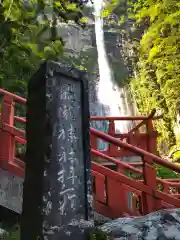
0, 95, 15, 169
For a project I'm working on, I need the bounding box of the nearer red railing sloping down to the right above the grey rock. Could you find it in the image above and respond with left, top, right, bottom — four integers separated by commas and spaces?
91, 129, 180, 217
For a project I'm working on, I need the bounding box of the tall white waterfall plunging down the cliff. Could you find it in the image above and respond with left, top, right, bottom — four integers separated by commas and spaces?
94, 0, 132, 149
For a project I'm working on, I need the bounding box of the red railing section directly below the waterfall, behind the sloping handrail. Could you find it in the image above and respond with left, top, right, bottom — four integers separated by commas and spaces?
90, 110, 161, 157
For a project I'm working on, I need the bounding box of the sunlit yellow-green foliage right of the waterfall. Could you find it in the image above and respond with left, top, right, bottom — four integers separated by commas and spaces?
107, 0, 180, 153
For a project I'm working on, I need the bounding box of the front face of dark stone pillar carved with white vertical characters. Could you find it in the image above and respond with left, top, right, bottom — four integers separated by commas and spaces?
43, 69, 92, 240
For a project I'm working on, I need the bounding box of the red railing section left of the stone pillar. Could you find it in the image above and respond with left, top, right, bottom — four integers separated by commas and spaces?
0, 89, 26, 176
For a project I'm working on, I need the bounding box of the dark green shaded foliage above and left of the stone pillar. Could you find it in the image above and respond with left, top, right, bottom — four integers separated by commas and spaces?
0, 0, 86, 94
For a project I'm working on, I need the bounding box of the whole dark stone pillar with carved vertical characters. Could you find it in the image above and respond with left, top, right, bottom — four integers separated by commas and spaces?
21, 62, 93, 240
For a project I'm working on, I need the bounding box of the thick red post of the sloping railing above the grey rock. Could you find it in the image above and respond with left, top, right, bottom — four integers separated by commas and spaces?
142, 157, 162, 214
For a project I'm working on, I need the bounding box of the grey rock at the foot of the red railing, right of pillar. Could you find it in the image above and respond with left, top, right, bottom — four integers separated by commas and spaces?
99, 209, 180, 240
